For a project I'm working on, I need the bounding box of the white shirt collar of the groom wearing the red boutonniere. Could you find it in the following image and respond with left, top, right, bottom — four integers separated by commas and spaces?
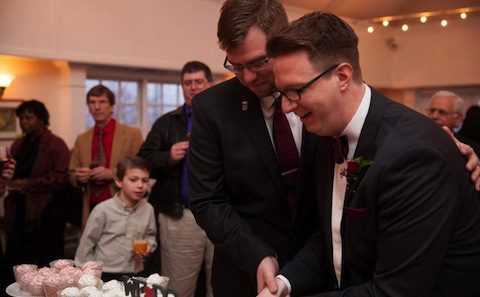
342, 84, 372, 160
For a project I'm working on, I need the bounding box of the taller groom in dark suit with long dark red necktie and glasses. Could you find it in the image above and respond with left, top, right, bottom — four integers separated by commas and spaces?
188, 0, 318, 297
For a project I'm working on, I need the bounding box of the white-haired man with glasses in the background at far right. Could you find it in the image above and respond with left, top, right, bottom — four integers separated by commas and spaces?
426, 90, 480, 155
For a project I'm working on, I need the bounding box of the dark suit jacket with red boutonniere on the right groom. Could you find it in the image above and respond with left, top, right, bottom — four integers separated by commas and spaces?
281, 90, 480, 297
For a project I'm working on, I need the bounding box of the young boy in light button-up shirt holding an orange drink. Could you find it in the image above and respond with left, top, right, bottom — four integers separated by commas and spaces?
75, 156, 157, 281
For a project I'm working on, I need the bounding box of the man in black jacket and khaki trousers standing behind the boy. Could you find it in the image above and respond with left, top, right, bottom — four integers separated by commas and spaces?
138, 61, 213, 297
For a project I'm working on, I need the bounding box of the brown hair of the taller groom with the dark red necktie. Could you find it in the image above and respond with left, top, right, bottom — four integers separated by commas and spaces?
217, 0, 288, 50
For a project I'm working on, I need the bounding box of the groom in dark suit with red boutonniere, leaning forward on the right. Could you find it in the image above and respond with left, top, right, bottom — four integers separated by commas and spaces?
260, 12, 480, 297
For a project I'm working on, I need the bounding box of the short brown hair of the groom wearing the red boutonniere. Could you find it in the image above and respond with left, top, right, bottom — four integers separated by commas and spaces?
267, 12, 362, 82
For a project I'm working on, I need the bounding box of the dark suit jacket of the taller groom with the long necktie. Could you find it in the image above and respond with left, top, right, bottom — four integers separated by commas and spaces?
188, 78, 318, 297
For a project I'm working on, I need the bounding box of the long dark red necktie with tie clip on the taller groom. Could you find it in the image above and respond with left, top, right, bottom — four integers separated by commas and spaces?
272, 100, 300, 211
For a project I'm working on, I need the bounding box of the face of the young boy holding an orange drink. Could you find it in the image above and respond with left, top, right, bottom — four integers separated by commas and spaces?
115, 168, 150, 203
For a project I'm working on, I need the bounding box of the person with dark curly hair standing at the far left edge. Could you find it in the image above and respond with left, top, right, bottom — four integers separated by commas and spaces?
5, 100, 70, 280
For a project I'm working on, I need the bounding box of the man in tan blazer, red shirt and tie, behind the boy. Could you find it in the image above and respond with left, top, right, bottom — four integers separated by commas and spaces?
69, 84, 143, 227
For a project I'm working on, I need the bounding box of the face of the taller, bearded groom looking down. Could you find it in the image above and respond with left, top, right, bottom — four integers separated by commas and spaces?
227, 26, 274, 97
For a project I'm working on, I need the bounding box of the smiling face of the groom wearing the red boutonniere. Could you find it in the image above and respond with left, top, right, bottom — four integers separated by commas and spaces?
273, 51, 349, 136
